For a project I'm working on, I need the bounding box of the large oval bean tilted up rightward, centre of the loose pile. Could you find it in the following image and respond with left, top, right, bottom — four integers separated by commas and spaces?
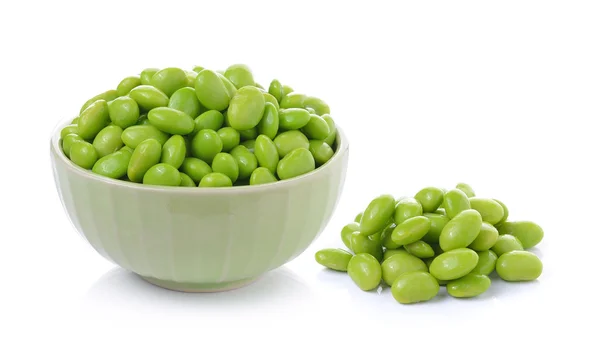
440, 209, 482, 251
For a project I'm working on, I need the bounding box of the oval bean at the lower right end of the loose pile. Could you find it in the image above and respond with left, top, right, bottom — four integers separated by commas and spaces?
496, 250, 544, 282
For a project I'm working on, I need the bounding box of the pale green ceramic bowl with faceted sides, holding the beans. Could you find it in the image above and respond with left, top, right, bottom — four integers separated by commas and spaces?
50, 120, 348, 292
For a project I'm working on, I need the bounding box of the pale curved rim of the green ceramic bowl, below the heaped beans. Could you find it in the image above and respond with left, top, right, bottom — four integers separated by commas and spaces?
50, 120, 349, 195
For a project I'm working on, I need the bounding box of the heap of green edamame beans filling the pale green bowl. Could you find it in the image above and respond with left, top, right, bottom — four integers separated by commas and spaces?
61, 64, 337, 187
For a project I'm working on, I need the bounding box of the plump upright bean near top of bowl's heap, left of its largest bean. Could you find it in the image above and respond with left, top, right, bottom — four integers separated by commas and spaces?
195, 69, 233, 111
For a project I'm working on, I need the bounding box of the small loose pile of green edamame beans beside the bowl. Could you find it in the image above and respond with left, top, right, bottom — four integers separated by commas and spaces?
315, 183, 544, 304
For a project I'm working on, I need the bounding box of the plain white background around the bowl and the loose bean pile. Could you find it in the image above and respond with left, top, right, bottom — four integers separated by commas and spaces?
0, 0, 600, 340
